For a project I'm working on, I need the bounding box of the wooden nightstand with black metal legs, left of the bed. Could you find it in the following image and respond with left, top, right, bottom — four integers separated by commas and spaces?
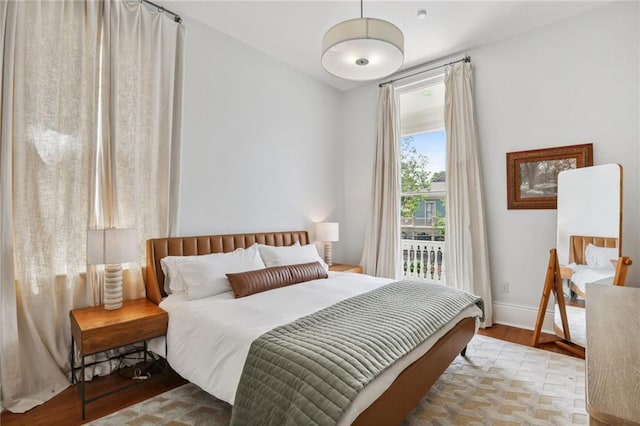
70, 299, 169, 420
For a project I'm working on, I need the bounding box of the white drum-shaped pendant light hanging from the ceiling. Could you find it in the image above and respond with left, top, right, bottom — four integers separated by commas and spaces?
322, 0, 404, 81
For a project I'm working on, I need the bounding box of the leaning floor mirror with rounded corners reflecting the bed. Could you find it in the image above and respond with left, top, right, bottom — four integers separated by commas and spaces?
554, 164, 622, 348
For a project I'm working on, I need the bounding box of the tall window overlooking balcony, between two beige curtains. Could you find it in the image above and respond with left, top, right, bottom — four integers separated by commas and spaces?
398, 77, 447, 284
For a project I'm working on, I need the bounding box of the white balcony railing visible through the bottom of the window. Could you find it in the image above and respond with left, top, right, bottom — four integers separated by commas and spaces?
400, 240, 445, 284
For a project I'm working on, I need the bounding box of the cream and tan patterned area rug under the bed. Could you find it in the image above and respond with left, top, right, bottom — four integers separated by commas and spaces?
90, 335, 588, 426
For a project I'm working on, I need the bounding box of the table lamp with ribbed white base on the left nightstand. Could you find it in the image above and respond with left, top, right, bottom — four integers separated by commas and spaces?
87, 228, 138, 310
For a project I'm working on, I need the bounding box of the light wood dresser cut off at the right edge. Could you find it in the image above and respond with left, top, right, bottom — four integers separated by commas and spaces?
586, 284, 640, 425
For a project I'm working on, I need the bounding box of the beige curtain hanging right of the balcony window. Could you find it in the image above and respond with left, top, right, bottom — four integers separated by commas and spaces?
444, 62, 493, 327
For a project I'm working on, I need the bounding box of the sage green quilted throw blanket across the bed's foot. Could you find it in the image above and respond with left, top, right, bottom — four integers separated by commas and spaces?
231, 281, 484, 426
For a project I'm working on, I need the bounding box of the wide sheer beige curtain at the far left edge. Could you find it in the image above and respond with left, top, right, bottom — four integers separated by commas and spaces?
0, 1, 101, 412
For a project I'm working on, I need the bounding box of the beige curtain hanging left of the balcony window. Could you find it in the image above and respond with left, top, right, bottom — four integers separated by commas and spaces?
360, 84, 402, 279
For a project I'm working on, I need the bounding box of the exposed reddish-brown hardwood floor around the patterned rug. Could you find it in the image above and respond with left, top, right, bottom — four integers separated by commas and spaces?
0, 325, 575, 426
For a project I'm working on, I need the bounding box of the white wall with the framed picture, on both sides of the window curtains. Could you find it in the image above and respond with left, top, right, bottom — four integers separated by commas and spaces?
344, 2, 640, 328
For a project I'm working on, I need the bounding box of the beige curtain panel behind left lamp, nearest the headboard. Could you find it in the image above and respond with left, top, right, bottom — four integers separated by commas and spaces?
90, 0, 185, 299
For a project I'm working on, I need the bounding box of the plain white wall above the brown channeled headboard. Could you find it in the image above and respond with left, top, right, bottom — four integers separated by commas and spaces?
178, 17, 343, 258
